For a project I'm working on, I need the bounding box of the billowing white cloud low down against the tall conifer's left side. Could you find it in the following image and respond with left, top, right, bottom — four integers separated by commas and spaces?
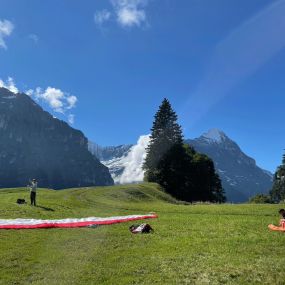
115, 135, 150, 184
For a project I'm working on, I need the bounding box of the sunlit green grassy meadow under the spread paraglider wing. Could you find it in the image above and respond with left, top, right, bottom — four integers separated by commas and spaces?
0, 184, 285, 285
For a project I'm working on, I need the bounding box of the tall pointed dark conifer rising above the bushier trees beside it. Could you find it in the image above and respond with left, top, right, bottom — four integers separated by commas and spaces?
143, 99, 185, 198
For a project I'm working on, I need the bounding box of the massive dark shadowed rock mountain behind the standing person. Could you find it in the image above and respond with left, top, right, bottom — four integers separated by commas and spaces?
0, 88, 114, 189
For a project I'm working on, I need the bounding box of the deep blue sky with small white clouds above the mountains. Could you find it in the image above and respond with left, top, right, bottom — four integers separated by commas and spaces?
0, 0, 285, 171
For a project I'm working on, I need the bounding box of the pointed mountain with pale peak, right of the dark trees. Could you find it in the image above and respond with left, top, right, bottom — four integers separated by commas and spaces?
186, 129, 272, 202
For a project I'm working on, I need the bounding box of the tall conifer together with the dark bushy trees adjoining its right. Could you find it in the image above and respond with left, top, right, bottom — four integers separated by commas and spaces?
143, 99, 225, 202
